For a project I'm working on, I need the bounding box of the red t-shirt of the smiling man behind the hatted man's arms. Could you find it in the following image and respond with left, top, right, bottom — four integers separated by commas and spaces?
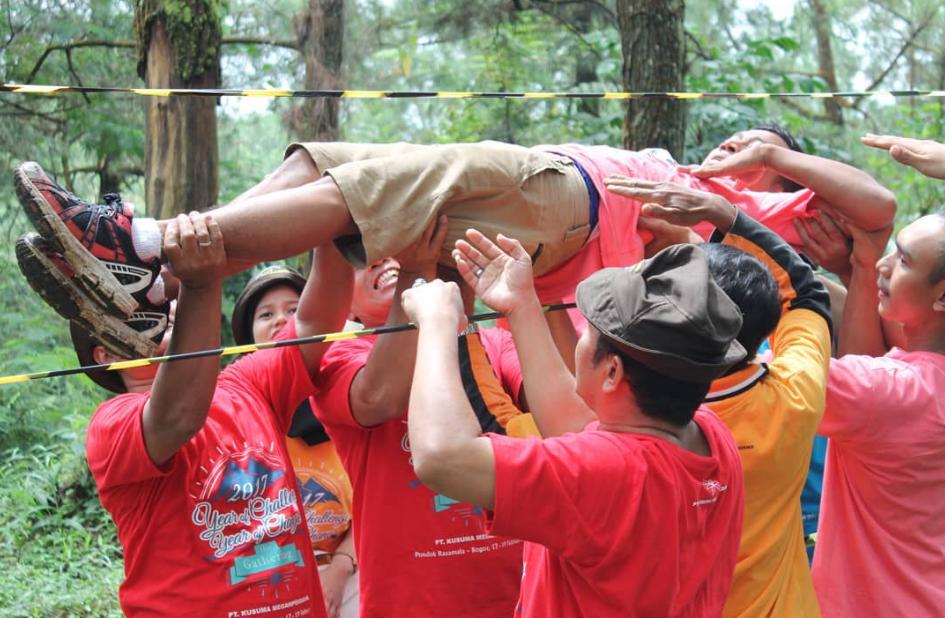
314, 330, 522, 618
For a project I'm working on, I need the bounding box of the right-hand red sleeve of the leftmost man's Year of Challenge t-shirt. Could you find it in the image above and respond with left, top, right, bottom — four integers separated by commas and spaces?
217, 320, 315, 430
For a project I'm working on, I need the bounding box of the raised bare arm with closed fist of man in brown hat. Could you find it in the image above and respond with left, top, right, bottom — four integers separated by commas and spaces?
403, 280, 495, 509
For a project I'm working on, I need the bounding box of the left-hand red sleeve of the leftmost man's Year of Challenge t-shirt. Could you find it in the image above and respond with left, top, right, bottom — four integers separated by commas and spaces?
85, 393, 170, 492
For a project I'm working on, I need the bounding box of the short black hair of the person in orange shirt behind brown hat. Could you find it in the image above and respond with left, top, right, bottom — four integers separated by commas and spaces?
702, 243, 781, 366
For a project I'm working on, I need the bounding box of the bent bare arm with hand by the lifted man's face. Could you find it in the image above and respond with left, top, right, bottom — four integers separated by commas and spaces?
691, 144, 896, 230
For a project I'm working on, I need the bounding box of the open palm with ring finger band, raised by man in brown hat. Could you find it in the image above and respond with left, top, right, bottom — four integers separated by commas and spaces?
453, 230, 537, 315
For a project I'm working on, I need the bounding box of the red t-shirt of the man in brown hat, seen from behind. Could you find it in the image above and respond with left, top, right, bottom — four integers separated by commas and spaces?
487, 408, 743, 618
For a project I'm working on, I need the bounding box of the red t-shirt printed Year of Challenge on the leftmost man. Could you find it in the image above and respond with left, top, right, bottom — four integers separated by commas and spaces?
86, 326, 325, 618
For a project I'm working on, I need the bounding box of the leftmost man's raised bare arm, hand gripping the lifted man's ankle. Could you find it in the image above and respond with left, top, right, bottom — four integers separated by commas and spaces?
142, 212, 226, 465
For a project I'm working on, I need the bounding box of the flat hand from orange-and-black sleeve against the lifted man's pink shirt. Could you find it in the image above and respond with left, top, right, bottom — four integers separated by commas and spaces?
604, 176, 737, 232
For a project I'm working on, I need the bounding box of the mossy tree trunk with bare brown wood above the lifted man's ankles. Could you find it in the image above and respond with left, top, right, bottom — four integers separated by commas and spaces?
135, 0, 221, 218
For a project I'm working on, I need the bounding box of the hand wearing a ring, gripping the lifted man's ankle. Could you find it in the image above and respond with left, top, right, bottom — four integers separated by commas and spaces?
163, 211, 226, 288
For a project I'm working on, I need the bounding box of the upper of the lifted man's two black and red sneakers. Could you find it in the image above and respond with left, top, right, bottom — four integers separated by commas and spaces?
14, 161, 161, 318
